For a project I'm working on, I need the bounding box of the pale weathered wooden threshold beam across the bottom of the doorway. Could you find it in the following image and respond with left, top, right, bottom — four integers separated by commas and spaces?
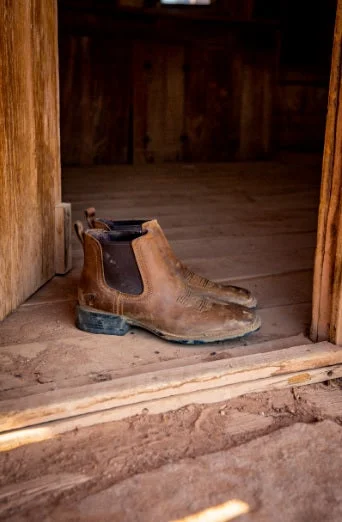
0, 342, 342, 451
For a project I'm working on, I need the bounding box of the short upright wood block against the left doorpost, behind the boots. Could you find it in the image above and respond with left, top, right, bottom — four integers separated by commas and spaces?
55, 203, 72, 275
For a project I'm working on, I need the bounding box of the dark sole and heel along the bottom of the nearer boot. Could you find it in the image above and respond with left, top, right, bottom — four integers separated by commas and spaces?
76, 305, 261, 344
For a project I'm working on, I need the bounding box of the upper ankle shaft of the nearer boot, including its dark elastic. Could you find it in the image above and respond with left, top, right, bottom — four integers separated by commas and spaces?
78, 220, 184, 306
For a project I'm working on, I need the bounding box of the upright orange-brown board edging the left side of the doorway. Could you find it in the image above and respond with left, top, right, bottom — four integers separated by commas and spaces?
33, 0, 62, 280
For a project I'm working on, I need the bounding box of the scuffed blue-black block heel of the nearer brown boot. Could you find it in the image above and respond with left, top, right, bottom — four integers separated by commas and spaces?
76, 306, 130, 335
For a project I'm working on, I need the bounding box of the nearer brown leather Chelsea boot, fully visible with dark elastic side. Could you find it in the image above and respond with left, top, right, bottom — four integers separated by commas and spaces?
75, 220, 261, 344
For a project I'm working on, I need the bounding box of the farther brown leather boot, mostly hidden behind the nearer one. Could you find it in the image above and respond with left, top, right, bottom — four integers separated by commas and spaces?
84, 207, 257, 308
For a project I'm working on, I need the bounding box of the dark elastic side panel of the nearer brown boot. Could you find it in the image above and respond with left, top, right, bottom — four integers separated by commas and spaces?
101, 241, 144, 295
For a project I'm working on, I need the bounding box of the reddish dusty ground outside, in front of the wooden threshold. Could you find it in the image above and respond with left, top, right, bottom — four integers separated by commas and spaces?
0, 380, 342, 522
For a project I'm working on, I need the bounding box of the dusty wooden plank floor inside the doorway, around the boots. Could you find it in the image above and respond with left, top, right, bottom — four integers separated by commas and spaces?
0, 156, 320, 400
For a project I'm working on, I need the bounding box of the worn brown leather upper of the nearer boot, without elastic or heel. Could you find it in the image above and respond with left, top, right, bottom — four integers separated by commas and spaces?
78, 220, 260, 341
